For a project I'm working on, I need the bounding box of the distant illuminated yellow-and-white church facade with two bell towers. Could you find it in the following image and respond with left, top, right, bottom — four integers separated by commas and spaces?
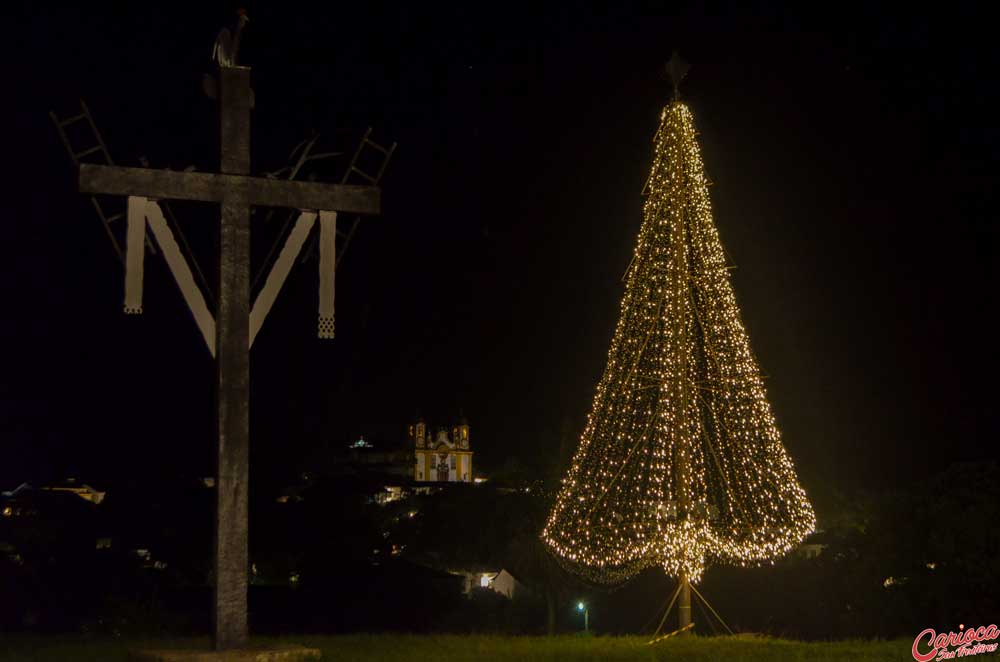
409, 418, 472, 483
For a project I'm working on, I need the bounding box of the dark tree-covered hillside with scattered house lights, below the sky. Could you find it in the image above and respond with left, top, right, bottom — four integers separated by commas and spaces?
0, 465, 1000, 638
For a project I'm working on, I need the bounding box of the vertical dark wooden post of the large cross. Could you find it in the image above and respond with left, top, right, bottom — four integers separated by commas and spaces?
214, 67, 250, 650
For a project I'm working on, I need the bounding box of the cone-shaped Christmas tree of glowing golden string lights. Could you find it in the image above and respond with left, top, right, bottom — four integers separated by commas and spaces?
542, 101, 816, 583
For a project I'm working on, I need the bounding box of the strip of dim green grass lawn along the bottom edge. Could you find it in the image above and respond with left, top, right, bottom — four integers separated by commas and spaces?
0, 634, 913, 662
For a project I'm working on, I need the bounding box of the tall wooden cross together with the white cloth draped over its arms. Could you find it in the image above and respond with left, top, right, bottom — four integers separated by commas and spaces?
74, 66, 381, 649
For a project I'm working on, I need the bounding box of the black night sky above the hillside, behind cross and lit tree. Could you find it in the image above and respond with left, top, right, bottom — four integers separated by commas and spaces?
0, 2, 1000, 516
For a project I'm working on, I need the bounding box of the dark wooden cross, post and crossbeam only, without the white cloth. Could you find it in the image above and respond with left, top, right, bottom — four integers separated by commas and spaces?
80, 66, 380, 650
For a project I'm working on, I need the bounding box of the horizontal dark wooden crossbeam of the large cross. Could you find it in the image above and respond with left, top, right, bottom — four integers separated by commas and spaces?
80, 163, 381, 215
